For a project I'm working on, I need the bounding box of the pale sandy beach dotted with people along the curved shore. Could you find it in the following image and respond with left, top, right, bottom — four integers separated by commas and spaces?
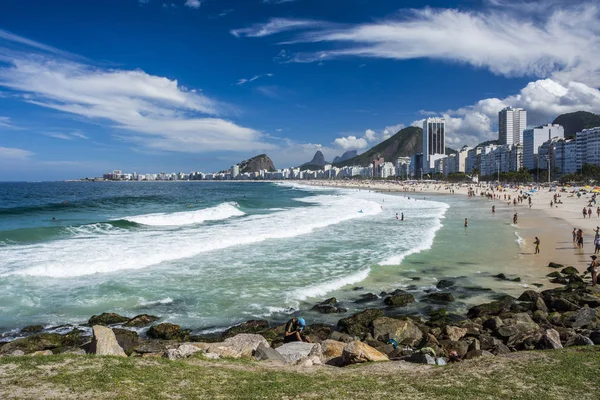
298, 181, 600, 280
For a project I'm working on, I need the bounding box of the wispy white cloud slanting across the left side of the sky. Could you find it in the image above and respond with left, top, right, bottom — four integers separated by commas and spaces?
0, 28, 273, 153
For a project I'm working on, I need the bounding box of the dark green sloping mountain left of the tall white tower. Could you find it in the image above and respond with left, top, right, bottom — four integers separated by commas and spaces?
334, 126, 456, 167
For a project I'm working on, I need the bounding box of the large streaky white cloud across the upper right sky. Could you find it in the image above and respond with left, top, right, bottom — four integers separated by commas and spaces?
233, 1, 600, 86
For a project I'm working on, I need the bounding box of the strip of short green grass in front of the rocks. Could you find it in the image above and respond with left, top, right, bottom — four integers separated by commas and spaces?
0, 346, 600, 400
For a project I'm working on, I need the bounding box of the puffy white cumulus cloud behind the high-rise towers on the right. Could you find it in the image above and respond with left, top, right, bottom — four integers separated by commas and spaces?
413, 79, 600, 147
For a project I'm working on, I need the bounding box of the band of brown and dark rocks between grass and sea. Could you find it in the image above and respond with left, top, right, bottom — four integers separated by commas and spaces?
0, 264, 600, 367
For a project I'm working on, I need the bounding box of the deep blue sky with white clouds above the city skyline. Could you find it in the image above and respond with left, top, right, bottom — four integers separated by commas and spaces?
0, 0, 600, 180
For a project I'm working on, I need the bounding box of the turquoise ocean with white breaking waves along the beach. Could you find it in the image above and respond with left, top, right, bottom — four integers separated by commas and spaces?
0, 182, 540, 338
